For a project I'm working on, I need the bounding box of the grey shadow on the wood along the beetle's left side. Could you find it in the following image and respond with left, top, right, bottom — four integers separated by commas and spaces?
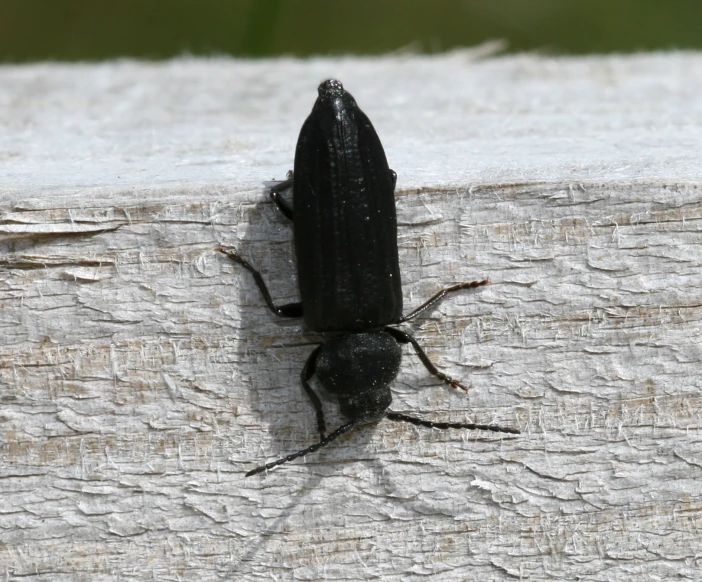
223, 192, 328, 454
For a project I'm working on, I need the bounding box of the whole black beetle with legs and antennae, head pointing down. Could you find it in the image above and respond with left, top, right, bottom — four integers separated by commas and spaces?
220, 79, 519, 477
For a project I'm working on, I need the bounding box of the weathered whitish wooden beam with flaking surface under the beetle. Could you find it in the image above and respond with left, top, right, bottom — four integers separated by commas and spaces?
0, 51, 702, 582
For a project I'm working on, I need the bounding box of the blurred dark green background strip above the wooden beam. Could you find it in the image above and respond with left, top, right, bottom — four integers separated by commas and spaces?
0, 0, 702, 62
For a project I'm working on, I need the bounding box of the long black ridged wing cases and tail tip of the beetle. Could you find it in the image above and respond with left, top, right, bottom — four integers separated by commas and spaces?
293, 80, 402, 331
